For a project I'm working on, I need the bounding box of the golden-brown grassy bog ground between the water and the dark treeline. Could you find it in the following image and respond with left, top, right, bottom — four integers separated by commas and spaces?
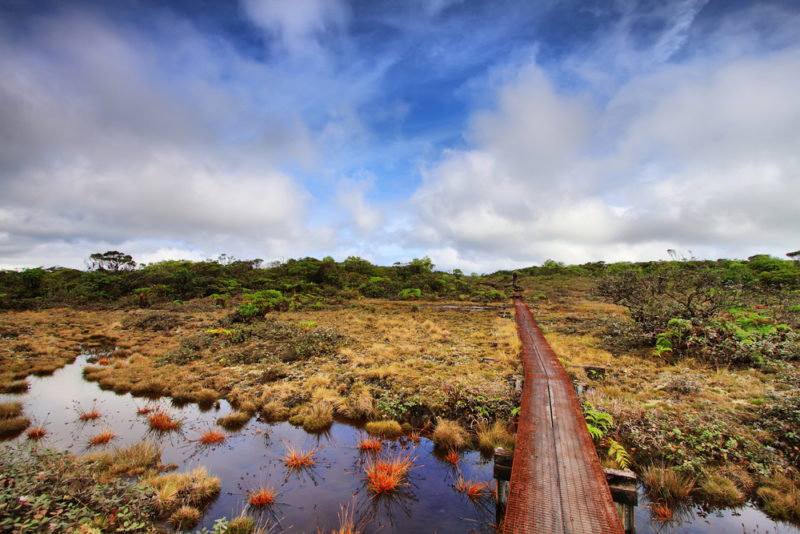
0, 261, 800, 531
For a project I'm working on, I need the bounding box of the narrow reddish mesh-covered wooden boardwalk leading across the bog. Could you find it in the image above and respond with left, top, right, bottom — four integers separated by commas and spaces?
503, 296, 623, 534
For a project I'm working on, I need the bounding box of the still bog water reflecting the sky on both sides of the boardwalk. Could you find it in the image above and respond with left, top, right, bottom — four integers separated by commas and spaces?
0, 356, 800, 534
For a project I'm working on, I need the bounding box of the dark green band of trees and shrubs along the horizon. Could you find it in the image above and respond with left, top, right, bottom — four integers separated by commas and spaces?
0, 251, 800, 309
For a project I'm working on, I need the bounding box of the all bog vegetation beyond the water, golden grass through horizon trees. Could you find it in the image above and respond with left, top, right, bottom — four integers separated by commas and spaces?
0, 251, 800, 528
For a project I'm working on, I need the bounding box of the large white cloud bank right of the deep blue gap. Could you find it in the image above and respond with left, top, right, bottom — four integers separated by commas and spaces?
406, 12, 800, 265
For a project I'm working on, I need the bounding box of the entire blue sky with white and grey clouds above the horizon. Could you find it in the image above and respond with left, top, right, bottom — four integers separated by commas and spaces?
0, 0, 800, 272
